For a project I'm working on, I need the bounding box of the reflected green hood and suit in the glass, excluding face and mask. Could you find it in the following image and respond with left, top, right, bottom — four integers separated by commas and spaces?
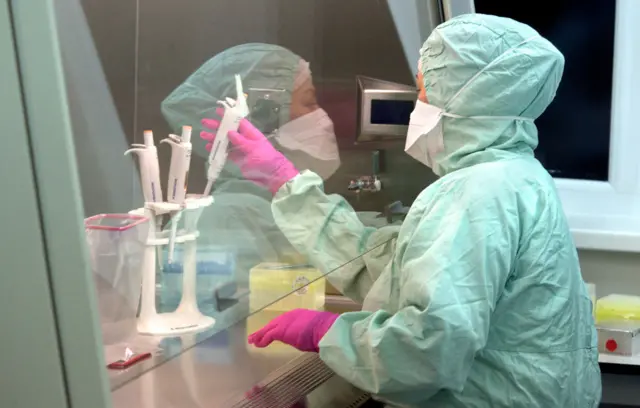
161, 43, 301, 284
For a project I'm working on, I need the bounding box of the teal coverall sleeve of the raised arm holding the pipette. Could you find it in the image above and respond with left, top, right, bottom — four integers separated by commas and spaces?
271, 171, 399, 304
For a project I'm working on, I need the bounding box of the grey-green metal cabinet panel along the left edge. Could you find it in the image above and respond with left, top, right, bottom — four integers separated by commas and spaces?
0, 0, 110, 408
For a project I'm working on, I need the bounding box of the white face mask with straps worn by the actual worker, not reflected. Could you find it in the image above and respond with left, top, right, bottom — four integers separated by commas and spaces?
404, 35, 539, 174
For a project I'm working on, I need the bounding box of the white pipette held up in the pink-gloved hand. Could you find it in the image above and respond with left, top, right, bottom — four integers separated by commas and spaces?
204, 75, 249, 196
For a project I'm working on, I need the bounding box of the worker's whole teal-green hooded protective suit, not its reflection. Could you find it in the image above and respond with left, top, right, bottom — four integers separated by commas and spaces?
272, 14, 601, 408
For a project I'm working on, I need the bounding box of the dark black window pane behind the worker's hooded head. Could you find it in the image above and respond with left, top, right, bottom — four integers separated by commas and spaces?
475, 0, 616, 181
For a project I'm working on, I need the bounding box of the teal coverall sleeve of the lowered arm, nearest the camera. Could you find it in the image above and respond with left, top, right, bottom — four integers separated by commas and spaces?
320, 191, 518, 405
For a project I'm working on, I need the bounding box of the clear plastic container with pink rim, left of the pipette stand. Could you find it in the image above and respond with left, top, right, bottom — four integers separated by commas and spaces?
84, 214, 149, 346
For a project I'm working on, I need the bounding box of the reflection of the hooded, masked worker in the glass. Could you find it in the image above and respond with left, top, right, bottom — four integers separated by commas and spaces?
162, 44, 340, 284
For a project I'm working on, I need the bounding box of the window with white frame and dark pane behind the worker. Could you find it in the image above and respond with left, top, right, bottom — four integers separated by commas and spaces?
464, 0, 640, 252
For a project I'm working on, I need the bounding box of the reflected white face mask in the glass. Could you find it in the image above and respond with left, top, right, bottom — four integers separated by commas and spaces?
275, 109, 340, 179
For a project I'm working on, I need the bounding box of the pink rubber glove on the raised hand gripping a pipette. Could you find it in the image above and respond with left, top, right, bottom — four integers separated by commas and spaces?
200, 108, 299, 194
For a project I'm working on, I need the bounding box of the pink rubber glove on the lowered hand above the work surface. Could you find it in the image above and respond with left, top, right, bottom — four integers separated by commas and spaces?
249, 309, 338, 353
